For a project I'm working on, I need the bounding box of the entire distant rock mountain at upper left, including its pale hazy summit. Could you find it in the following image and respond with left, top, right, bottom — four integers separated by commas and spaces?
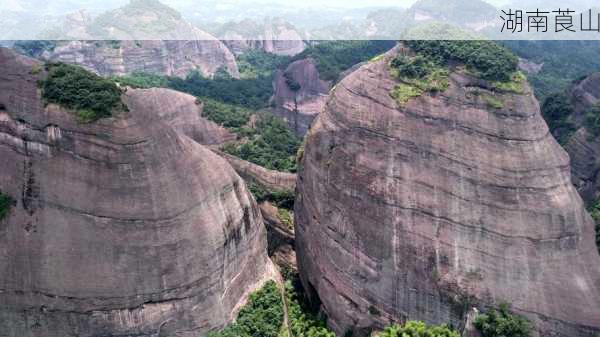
42, 0, 239, 78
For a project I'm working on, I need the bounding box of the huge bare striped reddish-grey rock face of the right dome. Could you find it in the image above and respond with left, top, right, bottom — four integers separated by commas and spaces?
295, 48, 600, 337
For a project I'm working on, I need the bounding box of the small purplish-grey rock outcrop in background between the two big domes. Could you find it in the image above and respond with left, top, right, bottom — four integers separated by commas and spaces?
273, 58, 331, 136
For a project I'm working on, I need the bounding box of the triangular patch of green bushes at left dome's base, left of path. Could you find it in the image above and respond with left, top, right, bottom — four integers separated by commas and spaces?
207, 281, 283, 337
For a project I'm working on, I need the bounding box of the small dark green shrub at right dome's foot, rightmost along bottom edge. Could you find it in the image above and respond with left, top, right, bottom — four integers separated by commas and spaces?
474, 304, 531, 337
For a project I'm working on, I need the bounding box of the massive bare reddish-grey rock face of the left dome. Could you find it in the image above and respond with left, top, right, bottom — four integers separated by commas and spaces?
0, 49, 271, 337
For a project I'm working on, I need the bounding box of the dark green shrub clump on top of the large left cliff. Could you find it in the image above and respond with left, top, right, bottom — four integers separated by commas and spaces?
40, 63, 121, 122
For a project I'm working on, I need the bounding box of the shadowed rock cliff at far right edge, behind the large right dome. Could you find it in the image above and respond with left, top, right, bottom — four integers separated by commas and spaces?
565, 73, 600, 204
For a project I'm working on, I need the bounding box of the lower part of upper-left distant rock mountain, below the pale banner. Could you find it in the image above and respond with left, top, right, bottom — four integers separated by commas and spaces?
42, 39, 239, 78
